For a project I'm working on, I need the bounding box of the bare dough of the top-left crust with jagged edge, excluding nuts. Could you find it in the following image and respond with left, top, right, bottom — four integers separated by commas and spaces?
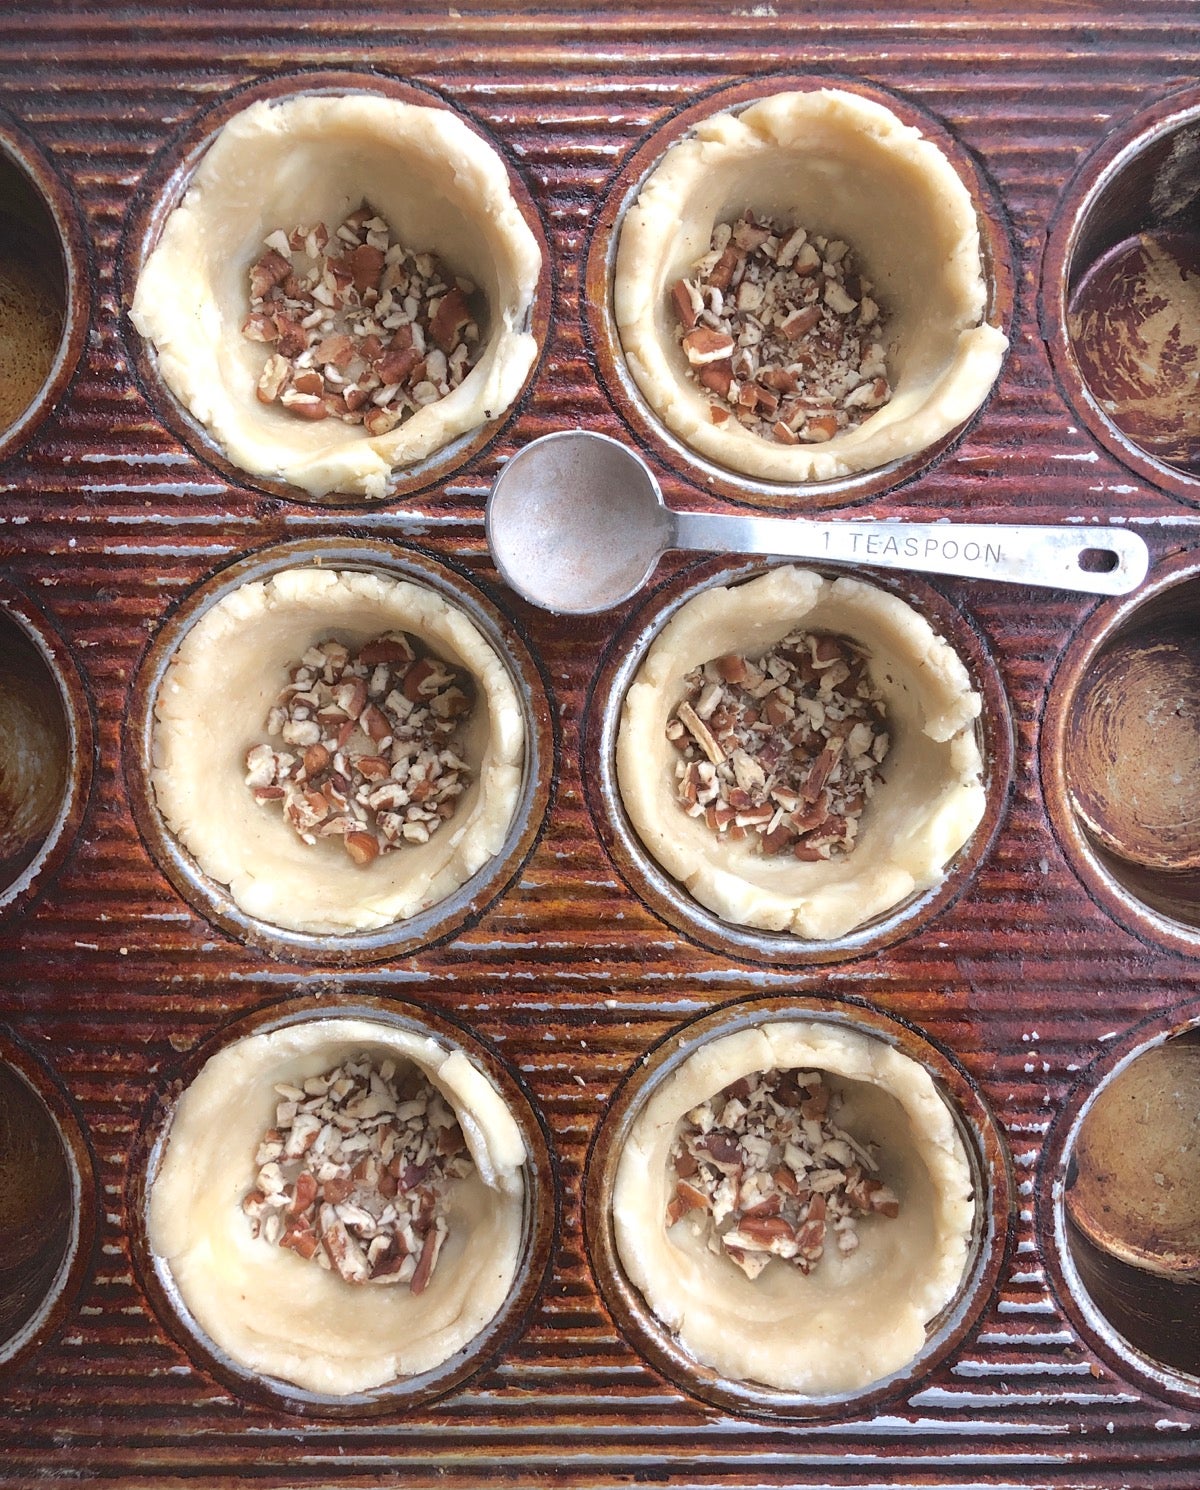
131, 94, 541, 498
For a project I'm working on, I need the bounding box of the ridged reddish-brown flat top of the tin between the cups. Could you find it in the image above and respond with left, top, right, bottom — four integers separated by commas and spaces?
0, 3, 1200, 1490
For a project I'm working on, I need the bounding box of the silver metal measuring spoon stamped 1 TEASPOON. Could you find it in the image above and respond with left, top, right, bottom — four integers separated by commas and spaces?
486, 429, 1149, 615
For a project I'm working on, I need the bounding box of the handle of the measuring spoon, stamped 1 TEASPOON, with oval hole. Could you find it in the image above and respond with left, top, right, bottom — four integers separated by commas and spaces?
671, 513, 1149, 595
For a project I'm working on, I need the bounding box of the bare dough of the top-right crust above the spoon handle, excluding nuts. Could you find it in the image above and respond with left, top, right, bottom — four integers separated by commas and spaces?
613, 88, 1008, 483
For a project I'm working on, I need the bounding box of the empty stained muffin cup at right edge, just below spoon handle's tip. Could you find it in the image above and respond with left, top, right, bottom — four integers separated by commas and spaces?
1042, 554, 1200, 949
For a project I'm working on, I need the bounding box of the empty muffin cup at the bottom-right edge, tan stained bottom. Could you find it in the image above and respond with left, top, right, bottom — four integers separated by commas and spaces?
1058, 1030, 1200, 1395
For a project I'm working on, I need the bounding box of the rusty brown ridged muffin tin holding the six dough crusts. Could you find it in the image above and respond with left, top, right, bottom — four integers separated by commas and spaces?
0, 0, 1200, 1490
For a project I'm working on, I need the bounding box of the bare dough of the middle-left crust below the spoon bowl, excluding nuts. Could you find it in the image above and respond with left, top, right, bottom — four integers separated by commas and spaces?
151, 568, 525, 933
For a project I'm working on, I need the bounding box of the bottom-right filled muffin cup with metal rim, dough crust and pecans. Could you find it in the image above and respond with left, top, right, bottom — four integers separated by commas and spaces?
586, 998, 1009, 1416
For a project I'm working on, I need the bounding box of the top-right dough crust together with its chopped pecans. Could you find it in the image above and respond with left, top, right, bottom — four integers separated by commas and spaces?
611, 86, 1006, 486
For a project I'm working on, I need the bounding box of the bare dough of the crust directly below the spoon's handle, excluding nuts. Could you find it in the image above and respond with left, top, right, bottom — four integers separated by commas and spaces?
617, 566, 987, 940
